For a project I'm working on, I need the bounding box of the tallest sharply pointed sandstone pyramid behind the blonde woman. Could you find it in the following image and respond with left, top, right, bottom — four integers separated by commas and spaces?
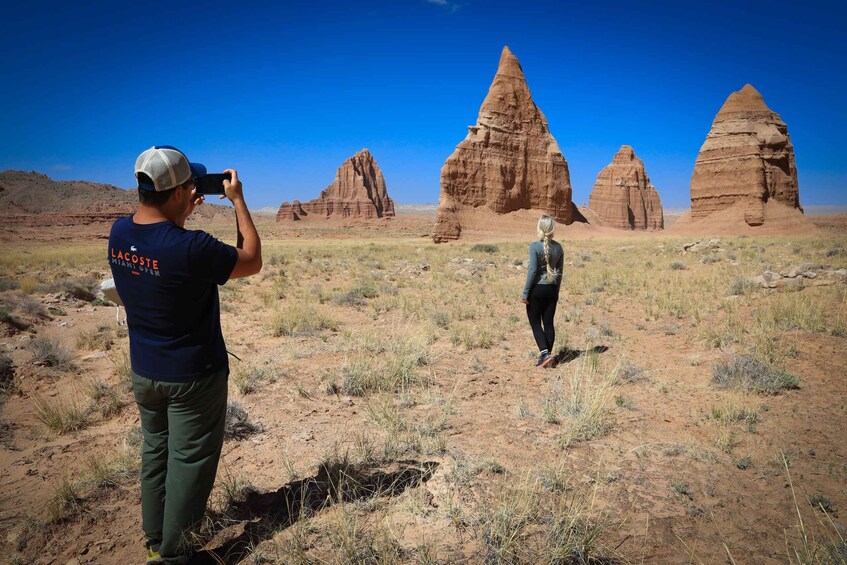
433, 47, 574, 243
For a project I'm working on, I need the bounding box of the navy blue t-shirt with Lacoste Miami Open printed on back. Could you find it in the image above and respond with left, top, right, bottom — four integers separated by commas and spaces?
109, 216, 238, 382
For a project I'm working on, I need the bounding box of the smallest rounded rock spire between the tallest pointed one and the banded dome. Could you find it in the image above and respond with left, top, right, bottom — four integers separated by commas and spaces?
588, 145, 665, 230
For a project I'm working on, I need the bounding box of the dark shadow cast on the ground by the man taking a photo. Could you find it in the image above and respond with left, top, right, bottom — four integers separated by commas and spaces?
191, 460, 438, 565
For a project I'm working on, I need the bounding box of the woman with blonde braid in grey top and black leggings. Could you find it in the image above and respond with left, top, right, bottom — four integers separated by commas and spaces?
521, 215, 565, 368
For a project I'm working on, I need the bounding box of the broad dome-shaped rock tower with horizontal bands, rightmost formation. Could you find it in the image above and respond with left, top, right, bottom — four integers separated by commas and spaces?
691, 84, 802, 226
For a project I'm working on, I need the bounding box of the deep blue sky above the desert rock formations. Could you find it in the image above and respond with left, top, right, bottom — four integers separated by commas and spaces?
0, 0, 847, 208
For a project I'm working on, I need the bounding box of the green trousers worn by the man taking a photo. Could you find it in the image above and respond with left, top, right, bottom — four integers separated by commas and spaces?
132, 369, 229, 563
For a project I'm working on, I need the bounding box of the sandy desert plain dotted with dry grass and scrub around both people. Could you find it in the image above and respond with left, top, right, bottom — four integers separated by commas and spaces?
0, 228, 847, 564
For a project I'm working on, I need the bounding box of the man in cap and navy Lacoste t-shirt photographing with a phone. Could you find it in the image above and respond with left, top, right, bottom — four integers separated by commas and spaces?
109, 146, 262, 564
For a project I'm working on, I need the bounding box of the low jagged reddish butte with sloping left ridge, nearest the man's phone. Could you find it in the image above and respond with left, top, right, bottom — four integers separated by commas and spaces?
276, 149, 394, 222
